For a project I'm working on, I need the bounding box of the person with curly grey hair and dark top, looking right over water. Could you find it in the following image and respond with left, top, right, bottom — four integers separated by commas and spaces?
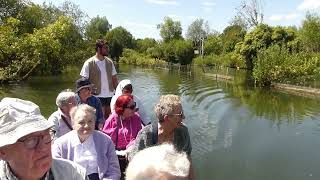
129, 94, 192, 159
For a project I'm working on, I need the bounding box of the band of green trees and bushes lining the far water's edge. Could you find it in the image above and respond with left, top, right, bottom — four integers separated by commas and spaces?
0, 0, 320, 94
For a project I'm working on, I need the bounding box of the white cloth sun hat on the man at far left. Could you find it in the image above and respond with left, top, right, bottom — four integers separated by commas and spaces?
0, 97, 53, 147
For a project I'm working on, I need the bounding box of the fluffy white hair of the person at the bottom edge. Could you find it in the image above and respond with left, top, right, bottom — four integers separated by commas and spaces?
126, 144, 190, 180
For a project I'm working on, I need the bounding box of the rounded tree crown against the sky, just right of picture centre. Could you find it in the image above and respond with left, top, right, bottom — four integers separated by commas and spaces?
157, 17, 183, 42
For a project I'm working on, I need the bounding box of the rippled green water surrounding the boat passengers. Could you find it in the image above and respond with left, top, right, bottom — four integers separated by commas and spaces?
0, 65, 320, 180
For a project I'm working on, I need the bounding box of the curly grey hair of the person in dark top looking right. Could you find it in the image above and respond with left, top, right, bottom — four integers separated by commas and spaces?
154, 94, 181, 123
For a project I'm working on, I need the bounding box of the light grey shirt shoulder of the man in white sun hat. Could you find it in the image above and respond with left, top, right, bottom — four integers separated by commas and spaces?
51, 158, 86, 179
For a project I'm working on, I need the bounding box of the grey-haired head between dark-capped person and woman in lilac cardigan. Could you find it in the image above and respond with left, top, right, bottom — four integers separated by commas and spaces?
56, 89, 78, 116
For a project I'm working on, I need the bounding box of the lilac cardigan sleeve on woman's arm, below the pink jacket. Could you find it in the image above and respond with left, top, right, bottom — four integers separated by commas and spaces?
102, 139, 121, 180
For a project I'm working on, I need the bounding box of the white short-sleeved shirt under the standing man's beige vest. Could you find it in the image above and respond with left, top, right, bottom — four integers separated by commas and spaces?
80, 56, 117, 97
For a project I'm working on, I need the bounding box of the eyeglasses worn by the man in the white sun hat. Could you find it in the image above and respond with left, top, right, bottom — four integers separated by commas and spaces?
17, 130, 55, 149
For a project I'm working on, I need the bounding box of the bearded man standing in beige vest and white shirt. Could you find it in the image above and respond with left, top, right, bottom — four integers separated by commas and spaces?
80, 39, 118, 119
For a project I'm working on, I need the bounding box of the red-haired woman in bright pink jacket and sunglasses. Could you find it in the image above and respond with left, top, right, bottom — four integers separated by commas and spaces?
102, 94, 141, 178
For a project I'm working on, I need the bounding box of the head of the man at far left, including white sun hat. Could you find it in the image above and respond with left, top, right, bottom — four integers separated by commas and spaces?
0, 98, 53, 179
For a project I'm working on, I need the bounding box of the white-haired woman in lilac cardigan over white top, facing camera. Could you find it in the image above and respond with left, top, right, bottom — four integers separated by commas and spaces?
52, 104, 120, 180
